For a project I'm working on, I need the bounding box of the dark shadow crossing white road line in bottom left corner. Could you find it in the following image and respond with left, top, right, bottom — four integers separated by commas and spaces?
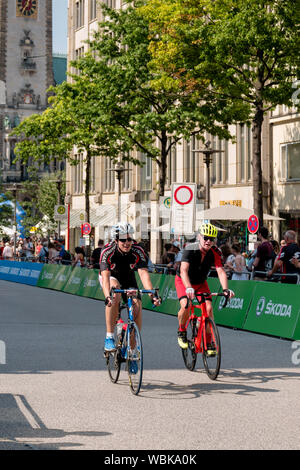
0, 393, 111, 450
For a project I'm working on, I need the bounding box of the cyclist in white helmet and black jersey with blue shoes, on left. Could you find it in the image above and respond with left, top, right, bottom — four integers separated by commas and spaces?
99, 222, 160, 351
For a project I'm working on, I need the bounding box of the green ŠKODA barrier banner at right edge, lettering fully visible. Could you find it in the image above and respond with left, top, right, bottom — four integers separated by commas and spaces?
240, 281, 300, 339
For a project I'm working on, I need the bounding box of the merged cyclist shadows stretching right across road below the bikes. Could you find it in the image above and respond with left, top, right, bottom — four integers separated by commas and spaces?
140, 369, 300, 400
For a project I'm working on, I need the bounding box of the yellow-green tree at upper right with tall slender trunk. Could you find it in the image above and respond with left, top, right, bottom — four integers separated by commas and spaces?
144, 0, 300, 224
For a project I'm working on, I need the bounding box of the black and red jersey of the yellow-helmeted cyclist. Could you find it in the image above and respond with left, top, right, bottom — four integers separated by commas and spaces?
176, 242, 223, 285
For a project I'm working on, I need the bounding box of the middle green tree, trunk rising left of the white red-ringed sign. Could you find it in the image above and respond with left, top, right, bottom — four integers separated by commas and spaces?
73, 1, 247, 195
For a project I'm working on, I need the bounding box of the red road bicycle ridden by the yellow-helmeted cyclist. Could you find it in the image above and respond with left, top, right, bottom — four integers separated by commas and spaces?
182, 292, 228, 380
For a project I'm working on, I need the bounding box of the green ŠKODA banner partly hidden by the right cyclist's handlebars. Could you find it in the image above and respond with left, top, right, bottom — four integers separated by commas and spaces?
214, 281, 255, 328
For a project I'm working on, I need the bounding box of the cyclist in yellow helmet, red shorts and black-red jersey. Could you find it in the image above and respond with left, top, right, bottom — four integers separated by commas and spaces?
175, 224, 234, 354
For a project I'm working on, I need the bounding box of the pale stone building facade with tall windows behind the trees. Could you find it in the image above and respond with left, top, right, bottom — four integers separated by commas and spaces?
66, 0, 300, 262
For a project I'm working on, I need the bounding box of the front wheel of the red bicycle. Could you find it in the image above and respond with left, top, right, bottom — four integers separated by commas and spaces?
202, 318, 221, 380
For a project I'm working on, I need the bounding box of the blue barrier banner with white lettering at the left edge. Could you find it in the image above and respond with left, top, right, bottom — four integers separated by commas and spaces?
0, 260, 43, 286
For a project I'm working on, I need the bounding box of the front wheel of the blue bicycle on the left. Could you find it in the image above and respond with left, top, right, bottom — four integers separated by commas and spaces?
126, 322, 143, 395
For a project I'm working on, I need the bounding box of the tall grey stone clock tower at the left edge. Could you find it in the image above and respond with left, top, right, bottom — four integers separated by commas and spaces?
0, 0, 54, 186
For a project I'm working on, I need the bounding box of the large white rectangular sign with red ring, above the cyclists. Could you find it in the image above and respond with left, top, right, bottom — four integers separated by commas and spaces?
170, 183, 197, 235
